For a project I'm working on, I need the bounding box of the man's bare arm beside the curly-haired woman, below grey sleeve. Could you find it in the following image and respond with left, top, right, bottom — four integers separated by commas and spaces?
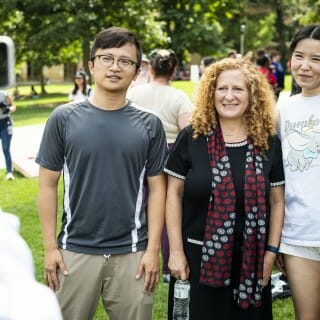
136, 174, 166, 293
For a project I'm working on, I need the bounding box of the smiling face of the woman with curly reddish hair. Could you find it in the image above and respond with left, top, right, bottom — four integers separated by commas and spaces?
215, 70, 249, 121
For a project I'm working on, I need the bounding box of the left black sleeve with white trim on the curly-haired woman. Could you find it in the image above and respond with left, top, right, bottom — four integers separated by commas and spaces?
164, 126, 191, 180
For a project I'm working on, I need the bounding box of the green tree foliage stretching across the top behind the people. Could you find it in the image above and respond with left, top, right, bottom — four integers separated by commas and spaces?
0, 0, 320, 87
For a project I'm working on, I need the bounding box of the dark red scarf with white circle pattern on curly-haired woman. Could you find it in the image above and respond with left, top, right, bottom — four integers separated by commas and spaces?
200, 126, 266, 309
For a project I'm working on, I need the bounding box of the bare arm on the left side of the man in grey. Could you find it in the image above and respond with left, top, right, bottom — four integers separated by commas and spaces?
38, 166, 67, 291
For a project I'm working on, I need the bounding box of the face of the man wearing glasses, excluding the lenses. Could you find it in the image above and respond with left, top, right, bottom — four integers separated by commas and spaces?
89, 43, 137, 93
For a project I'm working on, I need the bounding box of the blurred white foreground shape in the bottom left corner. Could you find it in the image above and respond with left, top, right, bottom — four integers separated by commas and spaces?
0, 211, 62, 320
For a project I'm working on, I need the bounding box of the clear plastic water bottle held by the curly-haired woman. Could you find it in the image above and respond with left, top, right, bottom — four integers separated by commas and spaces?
172, 280, 190, 320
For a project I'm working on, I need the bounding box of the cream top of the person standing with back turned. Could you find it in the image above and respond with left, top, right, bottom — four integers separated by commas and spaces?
127, 83, 193, 143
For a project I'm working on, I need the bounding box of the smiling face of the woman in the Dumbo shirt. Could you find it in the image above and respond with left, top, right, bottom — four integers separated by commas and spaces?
291, 39, 320, 96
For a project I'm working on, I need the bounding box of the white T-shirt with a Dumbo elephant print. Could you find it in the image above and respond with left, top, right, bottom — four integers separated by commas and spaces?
278, 94, 320, 247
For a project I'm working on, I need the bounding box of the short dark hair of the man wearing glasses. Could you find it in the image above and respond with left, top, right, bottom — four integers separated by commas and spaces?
90, 27, 142, 68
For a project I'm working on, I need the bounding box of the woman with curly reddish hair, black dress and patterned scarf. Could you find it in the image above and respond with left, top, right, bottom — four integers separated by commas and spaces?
165, 59, 284, 320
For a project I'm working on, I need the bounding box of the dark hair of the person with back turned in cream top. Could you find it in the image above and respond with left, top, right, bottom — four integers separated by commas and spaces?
150, 49, 178, 79
